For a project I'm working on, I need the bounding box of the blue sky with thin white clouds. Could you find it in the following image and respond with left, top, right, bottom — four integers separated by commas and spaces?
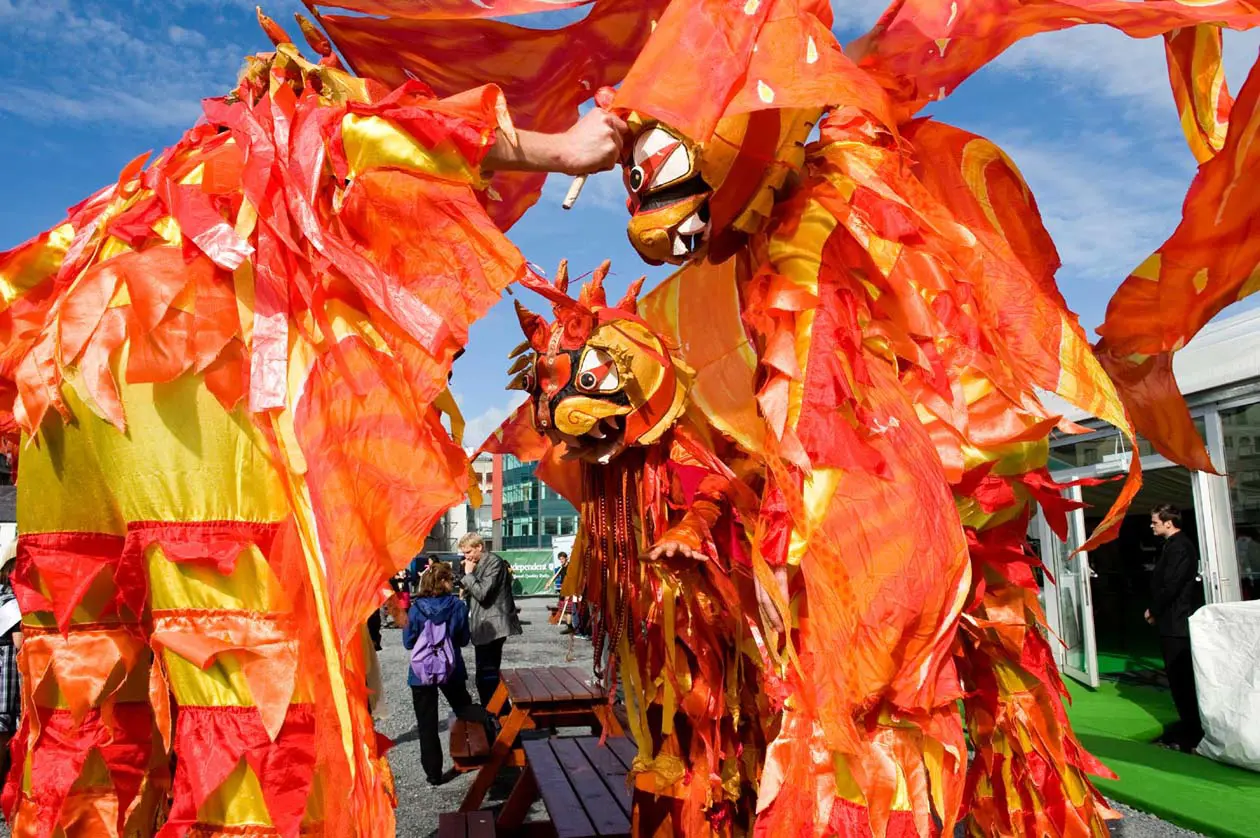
0, 0, 1260, 444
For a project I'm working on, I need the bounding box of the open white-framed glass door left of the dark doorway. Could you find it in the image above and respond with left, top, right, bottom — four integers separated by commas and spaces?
1041, 486, 1099, 687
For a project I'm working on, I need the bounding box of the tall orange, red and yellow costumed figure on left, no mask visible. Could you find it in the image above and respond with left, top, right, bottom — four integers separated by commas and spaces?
0, 11, 624, 838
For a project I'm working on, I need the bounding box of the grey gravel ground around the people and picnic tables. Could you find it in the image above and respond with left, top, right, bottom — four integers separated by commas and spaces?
0, 599, 1198, 838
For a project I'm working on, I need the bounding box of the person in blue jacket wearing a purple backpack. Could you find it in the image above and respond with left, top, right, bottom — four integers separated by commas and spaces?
402, 562, 473, 785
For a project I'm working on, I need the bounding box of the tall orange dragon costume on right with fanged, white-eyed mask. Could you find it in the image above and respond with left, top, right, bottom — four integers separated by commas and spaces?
388, 0, 1260, 835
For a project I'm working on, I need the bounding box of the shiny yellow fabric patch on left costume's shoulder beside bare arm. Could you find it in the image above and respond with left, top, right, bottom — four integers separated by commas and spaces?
341, 113, 480, 184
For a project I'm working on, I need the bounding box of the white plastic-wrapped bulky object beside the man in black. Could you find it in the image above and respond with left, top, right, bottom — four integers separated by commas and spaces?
1189, 602, 1260, 771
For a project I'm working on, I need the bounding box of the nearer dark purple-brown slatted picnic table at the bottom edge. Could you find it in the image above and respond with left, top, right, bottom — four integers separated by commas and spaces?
496, 736, 638, 838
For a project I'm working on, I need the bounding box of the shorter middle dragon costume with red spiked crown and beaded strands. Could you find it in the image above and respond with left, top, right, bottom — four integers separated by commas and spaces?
485, 263, 781, 834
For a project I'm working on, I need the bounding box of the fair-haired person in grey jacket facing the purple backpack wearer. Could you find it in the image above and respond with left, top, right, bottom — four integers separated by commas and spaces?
459, 533, 520, 706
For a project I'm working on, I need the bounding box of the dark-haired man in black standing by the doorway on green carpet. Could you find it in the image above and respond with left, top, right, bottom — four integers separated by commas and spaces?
1147, 504, 1203, 751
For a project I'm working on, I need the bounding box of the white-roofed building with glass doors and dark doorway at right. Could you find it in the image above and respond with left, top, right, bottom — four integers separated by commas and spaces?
1029, 303, 1260, 687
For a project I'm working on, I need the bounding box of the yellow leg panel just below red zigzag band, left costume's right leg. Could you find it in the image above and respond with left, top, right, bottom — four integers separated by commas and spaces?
145, 544, 282, 611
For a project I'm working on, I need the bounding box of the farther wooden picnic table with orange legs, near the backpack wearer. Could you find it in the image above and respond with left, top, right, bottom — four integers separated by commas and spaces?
460, 667, 622, 812
